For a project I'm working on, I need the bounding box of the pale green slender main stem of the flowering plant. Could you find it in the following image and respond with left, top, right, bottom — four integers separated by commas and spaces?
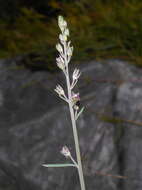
64, 44, 85, 190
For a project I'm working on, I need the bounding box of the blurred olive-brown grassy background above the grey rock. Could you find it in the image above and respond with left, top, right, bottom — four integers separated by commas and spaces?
0, 0, 142, 69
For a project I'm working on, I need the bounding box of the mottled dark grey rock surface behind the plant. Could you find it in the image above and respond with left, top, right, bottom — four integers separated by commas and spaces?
0, 60, 142, 190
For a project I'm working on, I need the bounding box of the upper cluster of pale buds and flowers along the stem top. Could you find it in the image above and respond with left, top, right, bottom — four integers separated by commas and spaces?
55, 16, 81, 110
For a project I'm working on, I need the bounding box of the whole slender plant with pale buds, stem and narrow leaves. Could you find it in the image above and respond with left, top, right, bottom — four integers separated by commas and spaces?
43, 16, 85, 190
